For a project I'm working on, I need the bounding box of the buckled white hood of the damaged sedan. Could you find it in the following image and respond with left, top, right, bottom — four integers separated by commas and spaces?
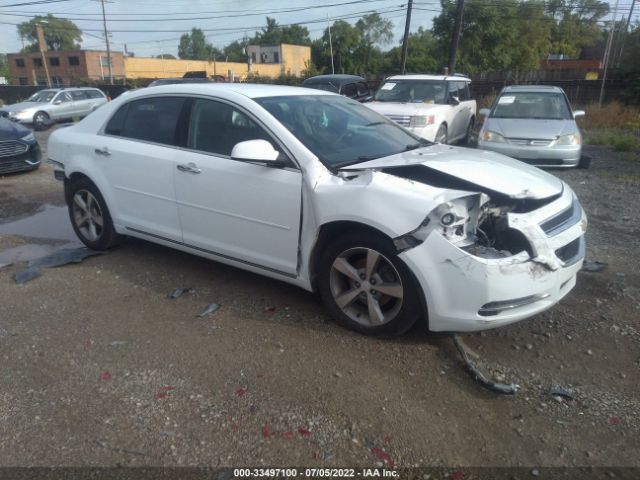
340, 144, 563, 200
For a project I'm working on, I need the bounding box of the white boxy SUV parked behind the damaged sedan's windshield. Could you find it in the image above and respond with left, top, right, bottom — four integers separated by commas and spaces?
367, 75, 476, 143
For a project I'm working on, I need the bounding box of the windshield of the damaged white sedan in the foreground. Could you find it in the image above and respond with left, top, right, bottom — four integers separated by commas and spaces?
255, 95, 431, 167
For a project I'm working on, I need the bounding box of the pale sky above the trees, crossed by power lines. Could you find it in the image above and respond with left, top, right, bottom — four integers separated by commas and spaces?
0, 0, 640, 57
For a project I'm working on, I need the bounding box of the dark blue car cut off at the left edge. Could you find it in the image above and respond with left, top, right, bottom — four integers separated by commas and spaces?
0, 117, 41, 175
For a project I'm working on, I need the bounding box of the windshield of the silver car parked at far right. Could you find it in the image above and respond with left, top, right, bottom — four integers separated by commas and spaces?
491, 92, 573, 120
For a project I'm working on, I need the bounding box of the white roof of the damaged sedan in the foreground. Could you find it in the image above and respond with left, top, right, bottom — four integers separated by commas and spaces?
125, 82, 335, 98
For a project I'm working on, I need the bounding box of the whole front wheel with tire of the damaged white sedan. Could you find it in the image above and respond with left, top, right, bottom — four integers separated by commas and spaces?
318, 232, 423, 336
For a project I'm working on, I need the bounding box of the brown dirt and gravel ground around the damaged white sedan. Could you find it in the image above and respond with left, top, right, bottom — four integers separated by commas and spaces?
0, 124, 640, 472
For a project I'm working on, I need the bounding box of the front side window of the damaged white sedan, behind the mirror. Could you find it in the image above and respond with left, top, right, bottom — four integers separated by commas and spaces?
187, 99, 277, 157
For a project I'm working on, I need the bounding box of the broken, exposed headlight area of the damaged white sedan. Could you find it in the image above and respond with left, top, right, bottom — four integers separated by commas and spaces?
393, 193, 489, 252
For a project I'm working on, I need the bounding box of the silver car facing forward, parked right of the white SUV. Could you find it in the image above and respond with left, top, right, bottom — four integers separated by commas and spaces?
478, 85, 588, 167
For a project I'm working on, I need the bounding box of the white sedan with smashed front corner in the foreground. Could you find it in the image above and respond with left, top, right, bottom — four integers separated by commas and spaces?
48, 84, 586, 335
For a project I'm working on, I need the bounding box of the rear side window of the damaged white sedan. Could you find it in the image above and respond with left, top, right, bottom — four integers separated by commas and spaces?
105, 97, 185, 145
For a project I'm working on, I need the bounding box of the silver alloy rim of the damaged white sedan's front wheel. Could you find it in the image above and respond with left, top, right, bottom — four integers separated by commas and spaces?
329, 247, 404, 327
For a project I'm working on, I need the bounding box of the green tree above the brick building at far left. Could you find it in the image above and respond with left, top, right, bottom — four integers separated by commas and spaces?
17, 14, 82, 52
